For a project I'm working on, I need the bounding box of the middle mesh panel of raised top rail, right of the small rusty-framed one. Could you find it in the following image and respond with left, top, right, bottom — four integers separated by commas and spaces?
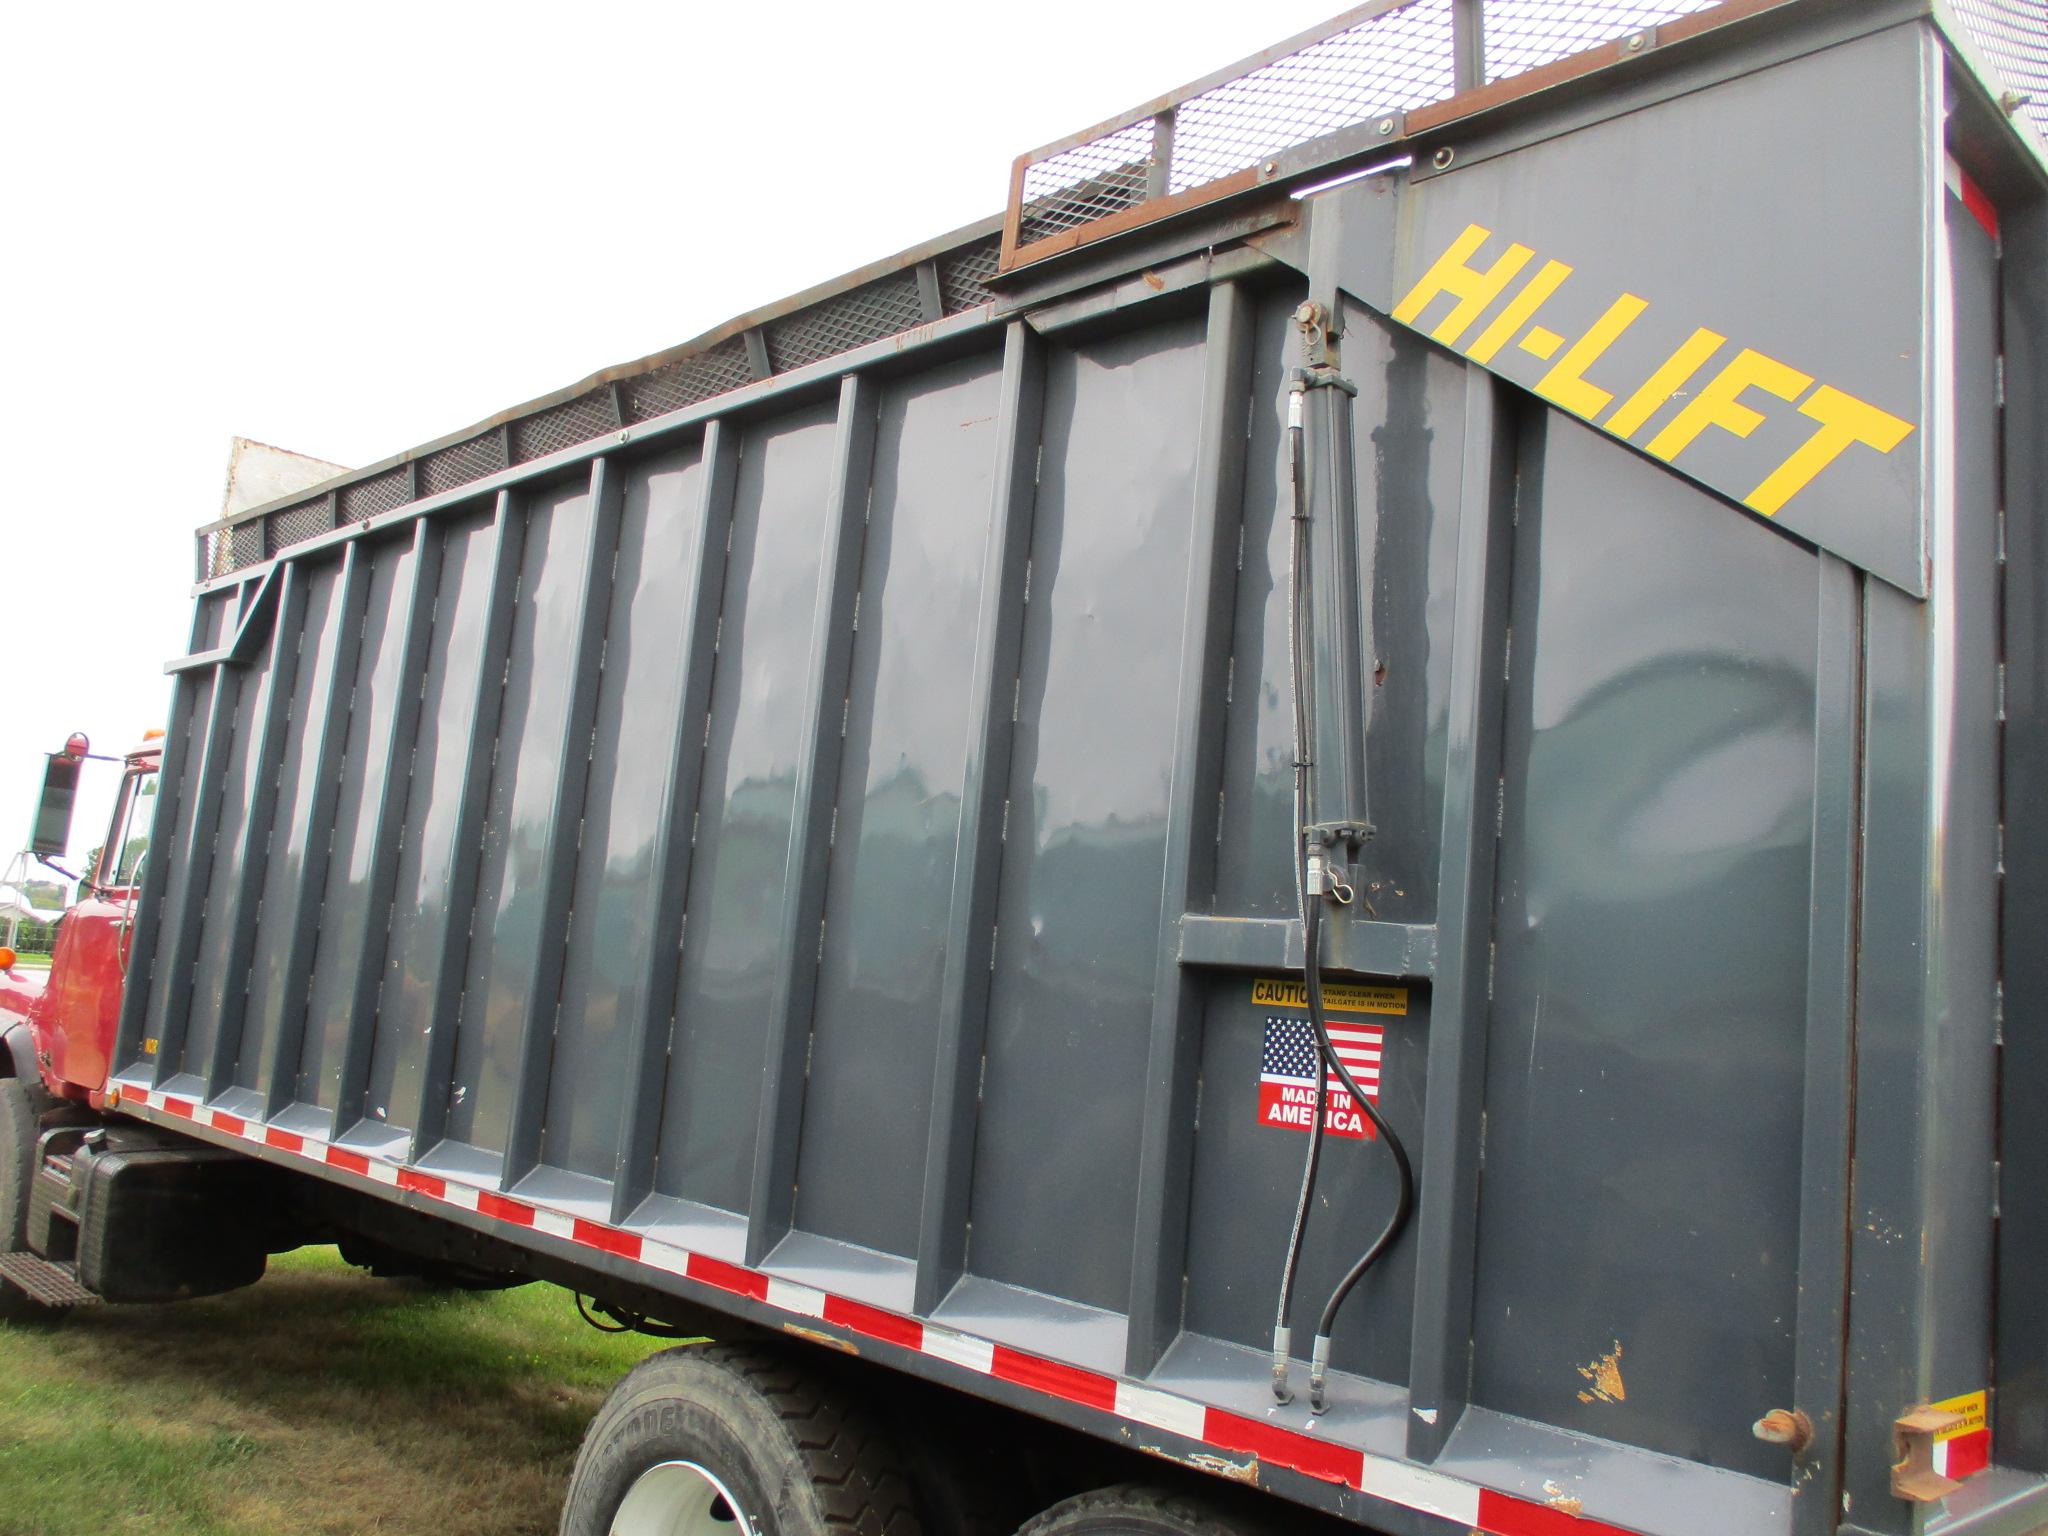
1167, 0, 1456, 193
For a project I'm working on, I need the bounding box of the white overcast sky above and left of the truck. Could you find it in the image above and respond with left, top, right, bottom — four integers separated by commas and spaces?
0, 0, 1341, 876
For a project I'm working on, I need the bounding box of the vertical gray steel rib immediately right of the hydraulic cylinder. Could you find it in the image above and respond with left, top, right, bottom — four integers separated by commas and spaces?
1407, 369, 1516, 1462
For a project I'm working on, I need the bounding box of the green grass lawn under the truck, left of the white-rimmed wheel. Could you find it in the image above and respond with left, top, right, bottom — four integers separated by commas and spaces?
0, 1249, 662, 1536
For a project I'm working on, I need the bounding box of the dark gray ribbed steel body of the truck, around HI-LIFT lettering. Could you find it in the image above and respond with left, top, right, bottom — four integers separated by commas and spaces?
121, 4, 2048, 1536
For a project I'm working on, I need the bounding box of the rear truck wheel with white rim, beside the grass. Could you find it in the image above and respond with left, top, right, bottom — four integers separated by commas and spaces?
561, 1343, 922, 1536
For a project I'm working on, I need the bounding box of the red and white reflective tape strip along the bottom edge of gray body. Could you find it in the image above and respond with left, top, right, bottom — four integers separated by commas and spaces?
117, 1083, 1636, 1536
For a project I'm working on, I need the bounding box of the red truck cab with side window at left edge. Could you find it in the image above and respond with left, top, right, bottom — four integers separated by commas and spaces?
0, 733, 164, 1106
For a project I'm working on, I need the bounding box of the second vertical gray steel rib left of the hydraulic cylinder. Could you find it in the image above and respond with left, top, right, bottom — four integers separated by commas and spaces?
915, 319, 1044, 1313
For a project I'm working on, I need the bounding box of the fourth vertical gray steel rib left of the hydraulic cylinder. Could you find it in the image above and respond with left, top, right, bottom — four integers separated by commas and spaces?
612, 420, 739, 1221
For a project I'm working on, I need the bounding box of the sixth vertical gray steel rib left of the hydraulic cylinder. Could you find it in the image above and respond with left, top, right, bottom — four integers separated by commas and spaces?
412, 492, 526, 1159
